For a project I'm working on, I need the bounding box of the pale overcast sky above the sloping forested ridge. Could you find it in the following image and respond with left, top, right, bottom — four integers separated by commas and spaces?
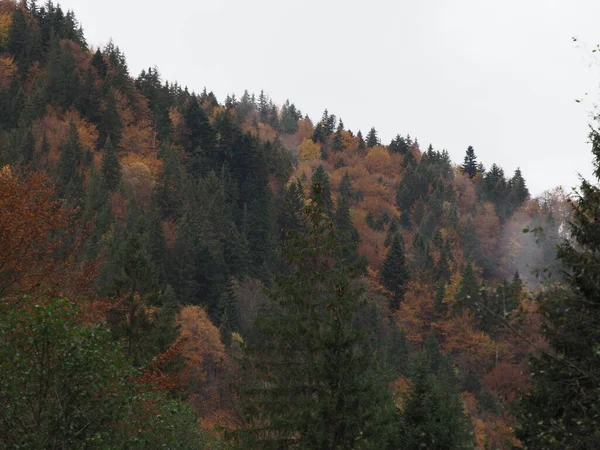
61, 0, 600, 194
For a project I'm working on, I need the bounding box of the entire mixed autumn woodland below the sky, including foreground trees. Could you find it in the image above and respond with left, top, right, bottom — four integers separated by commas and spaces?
0, 0, 600, 450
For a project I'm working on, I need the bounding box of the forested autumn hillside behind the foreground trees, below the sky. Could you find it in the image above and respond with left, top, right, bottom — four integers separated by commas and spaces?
0, 1, 570, 448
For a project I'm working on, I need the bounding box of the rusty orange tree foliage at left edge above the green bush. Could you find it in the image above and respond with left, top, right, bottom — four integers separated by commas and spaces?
0, 166, 96, 299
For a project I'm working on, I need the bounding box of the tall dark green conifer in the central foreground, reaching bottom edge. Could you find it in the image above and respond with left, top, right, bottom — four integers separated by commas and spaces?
233, 184, 390, 450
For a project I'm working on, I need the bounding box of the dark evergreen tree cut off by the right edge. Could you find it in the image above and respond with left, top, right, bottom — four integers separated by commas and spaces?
519, 125, 600, 450
